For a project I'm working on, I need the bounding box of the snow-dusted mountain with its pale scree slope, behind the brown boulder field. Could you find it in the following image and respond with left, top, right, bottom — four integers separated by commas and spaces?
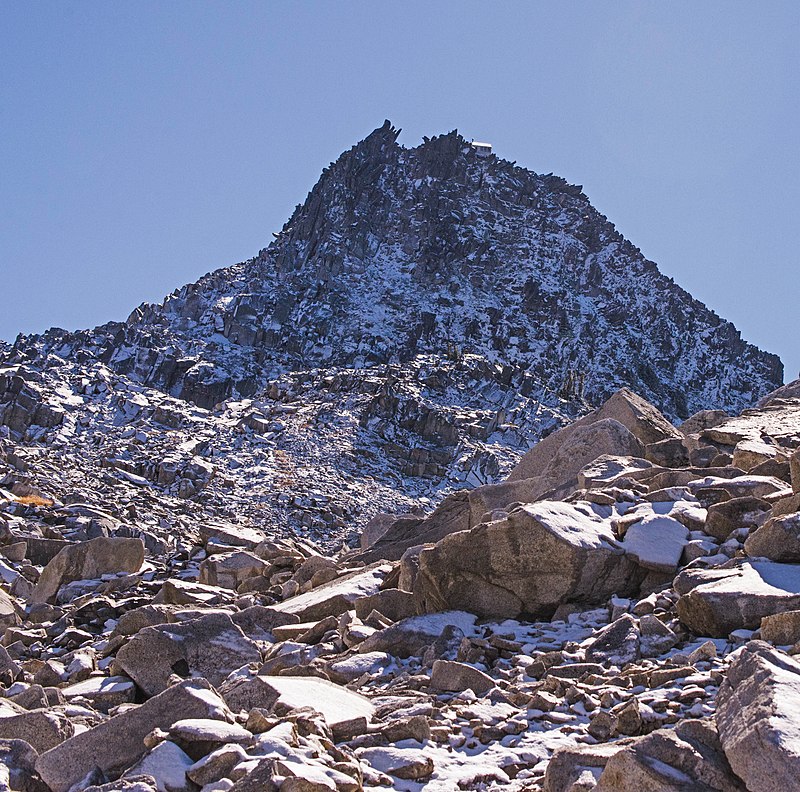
0, 122, 782, 548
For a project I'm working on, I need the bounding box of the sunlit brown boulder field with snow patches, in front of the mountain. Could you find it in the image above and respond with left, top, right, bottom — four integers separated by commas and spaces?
0, 383, 800, 792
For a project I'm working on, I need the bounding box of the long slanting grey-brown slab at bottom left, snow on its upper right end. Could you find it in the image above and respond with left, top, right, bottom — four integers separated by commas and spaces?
36, 679, 233, 792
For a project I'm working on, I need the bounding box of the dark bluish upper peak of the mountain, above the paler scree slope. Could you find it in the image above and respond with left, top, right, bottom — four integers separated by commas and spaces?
7, 122, 783, 418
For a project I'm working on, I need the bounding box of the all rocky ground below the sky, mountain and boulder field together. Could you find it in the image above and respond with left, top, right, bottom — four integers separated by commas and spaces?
0, 122, 800, 792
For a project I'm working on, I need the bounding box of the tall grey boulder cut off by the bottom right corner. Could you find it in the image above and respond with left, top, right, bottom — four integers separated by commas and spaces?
716, 641, 800, 792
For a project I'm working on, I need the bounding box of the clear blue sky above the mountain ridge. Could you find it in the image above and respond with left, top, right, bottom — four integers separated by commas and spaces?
0, 0, 800, 381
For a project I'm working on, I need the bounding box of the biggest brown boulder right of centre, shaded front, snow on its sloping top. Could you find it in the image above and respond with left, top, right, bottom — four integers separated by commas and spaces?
414, 501, 644, 619
